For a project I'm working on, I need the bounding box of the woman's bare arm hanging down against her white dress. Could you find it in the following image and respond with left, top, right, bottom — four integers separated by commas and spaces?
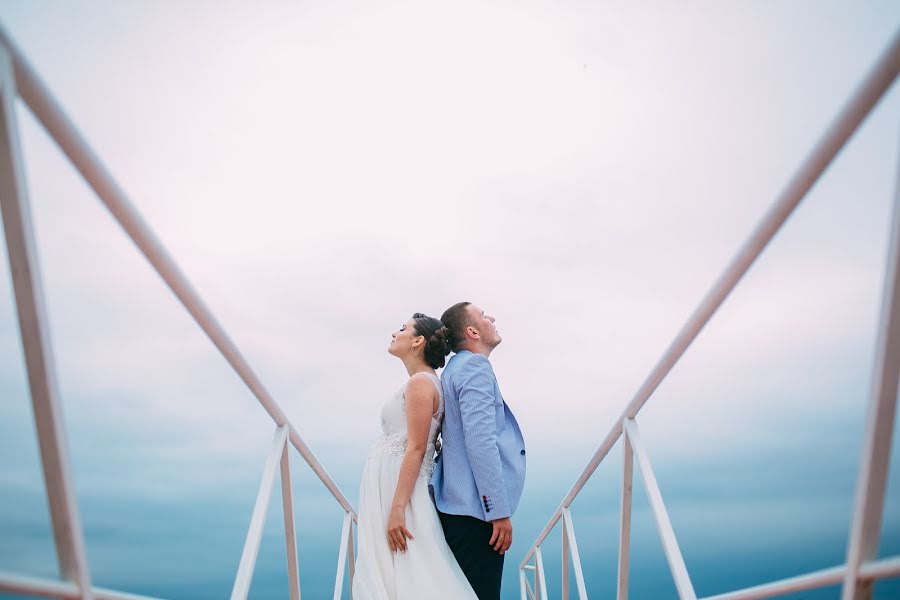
387, 375, 437, 552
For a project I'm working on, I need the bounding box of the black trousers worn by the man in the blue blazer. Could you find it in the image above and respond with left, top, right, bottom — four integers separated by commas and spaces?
438, 511, 503, 600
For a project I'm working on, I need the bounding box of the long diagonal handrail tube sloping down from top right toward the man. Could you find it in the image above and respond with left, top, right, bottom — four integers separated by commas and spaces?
521, 27, 900, 565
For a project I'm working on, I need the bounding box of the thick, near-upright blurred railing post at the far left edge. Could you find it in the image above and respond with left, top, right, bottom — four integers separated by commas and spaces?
0, 46, 92, 598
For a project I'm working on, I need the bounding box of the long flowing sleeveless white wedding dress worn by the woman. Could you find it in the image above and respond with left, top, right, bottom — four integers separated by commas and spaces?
353, 374, 477, 600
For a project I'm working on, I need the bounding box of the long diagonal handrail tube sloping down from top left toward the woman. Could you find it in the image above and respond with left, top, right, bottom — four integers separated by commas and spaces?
0, 23, 356, 520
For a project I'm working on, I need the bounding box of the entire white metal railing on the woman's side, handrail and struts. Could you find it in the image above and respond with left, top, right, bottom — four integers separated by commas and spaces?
0, 27, 356, 600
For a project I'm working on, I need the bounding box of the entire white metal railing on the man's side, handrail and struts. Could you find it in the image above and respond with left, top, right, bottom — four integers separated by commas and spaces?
519, 27, 900, 600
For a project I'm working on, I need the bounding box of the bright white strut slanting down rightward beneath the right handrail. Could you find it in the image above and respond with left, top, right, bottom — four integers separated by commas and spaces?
625, 419, 697, 600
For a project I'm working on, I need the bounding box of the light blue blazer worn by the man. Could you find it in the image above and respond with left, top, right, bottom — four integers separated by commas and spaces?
430, 350, 525, 521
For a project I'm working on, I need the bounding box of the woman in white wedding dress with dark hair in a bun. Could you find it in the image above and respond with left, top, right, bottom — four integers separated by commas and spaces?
353, 313, 476, 600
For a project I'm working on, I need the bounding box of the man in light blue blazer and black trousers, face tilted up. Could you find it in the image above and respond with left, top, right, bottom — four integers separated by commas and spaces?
431, 302, 525, 600
